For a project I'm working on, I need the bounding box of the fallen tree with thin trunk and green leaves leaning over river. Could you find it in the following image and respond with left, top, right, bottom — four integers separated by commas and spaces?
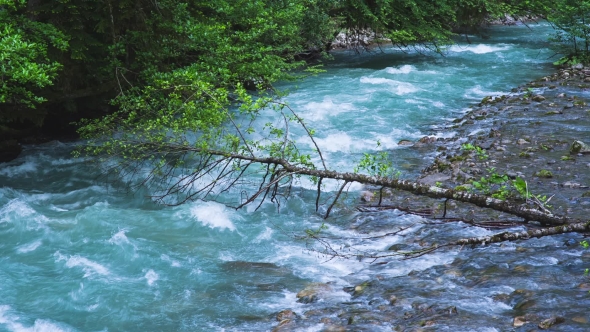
80, 90, 590, 259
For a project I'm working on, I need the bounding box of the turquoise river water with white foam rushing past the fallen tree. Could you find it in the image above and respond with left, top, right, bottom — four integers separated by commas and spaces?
0, 24, 588, 331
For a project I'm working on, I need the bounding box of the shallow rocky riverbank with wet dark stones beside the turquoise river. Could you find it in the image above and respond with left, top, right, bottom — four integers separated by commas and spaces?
271, 66, 590, 331
